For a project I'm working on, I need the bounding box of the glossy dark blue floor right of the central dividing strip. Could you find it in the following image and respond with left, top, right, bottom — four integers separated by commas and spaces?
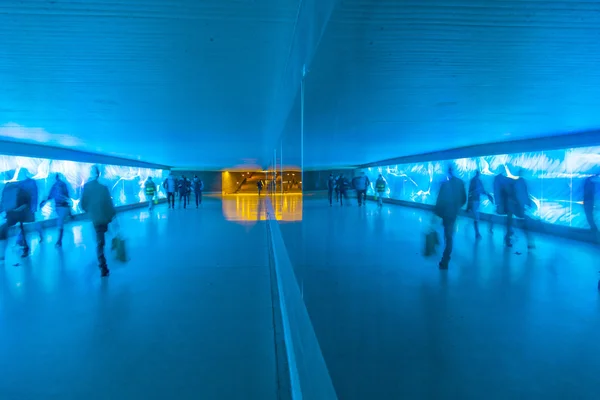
281, 198, 600, 400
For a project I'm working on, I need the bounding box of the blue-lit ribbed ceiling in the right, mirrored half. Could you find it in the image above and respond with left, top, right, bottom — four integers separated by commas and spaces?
302, 0, 600, 167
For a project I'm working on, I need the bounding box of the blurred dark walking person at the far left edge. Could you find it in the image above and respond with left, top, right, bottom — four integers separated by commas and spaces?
0, 177, 37, 261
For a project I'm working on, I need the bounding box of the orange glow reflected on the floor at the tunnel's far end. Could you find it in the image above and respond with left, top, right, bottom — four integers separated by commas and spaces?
223, 193, 302, 223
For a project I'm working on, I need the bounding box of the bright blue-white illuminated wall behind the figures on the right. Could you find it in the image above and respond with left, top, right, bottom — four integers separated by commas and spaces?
363, 147, 600, 229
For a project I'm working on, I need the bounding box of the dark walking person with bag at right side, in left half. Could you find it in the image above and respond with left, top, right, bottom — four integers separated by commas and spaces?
81, 166, 116, 277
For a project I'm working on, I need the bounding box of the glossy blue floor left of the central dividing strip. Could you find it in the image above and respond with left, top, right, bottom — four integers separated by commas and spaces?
0, 199, 277, 400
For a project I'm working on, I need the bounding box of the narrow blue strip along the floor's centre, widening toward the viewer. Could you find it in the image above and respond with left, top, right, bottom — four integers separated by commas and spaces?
265, 198, 337, 400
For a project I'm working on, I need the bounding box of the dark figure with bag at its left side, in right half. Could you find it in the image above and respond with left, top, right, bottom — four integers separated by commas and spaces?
435, 167, 467, 269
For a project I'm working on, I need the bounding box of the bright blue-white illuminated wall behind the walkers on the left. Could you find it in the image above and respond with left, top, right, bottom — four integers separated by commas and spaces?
0, 155, 168, 219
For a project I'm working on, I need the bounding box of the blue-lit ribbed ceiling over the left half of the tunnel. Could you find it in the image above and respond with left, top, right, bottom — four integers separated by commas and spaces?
0, 0, 299, 168
